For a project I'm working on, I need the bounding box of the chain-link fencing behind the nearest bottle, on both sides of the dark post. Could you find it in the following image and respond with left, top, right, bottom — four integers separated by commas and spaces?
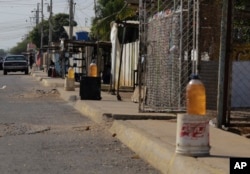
138, 0, 250, 126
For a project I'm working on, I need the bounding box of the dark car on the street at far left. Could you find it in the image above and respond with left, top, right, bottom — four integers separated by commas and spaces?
3, 55, 29, 75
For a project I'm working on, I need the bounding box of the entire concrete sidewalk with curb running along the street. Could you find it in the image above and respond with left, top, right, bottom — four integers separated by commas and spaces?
32, 71, 250, 174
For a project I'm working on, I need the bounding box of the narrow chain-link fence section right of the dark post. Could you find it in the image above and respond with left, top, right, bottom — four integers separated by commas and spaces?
226, 1, 250, 127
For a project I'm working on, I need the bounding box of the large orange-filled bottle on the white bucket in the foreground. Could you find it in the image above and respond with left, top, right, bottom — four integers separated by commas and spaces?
186, 75, 206, 116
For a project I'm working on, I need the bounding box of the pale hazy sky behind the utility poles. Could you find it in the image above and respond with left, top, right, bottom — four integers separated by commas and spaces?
0, 0, 94, 50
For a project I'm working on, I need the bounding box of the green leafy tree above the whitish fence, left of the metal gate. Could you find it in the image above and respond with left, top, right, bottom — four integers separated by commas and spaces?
91, 0, 137, 41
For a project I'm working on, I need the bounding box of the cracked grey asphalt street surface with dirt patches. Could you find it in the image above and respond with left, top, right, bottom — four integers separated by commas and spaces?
0, 71, 159, 174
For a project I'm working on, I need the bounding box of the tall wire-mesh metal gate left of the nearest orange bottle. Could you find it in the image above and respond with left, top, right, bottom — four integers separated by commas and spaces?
138, 0, 199, 112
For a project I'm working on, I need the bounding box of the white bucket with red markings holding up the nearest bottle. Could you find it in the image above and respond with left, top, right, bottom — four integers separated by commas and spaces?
176, 114, 210, 156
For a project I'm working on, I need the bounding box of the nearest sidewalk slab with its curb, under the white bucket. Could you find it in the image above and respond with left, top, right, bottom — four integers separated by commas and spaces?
110, 120, 250, 174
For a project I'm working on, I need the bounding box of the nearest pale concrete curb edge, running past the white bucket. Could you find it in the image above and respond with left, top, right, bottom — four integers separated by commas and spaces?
109, 120, 226, 174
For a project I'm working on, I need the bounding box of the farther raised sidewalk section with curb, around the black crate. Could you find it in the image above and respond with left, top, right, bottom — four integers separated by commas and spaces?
57, 88, 176, 123
